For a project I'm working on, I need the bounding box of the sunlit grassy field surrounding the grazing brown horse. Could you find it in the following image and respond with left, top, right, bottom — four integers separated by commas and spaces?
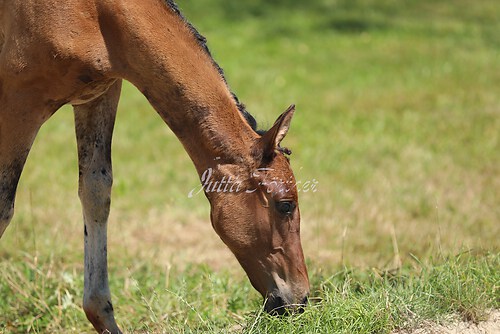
0, 0, 500, 333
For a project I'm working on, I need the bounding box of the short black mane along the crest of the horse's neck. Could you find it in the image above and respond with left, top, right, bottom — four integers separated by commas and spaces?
165, 0, 265, 135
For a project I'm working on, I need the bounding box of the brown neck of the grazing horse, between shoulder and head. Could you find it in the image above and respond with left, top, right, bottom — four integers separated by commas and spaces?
101, 0, 258, 175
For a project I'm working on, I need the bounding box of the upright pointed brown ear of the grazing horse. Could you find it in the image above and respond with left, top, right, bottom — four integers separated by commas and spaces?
260, 104, 295, 159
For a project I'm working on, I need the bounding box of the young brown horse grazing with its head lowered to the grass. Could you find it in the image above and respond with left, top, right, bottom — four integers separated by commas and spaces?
0, 0, 309, 333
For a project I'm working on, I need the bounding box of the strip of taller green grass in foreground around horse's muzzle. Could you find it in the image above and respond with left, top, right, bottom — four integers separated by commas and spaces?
0, 253, 500, 334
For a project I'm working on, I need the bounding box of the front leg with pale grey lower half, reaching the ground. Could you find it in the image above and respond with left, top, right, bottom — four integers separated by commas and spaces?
74, 81, 121, 333
